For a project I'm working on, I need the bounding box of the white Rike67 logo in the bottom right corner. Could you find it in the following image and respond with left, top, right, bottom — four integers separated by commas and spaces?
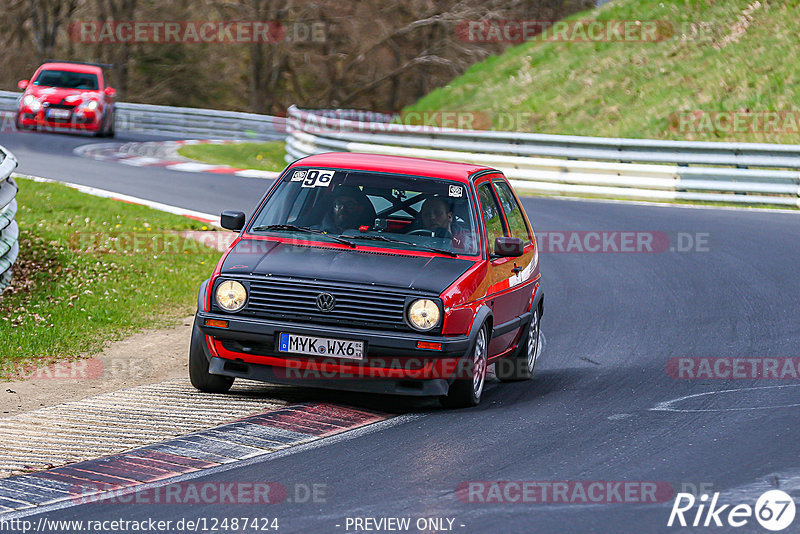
667, 490, 795, 532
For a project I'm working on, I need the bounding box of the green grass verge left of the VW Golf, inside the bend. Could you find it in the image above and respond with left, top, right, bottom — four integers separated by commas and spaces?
0, 180, 219, 378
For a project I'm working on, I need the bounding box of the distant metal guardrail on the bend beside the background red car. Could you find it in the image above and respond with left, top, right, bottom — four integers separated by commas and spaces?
0, 91, 286, 141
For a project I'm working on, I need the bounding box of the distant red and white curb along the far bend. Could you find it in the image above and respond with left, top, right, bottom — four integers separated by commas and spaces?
73, 140, 280, 179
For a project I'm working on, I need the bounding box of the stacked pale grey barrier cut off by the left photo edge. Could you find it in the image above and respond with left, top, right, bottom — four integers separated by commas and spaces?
0, 146, 19, 293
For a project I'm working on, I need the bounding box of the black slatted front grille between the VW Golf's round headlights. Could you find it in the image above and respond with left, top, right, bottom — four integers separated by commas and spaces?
238, 279, 409, 330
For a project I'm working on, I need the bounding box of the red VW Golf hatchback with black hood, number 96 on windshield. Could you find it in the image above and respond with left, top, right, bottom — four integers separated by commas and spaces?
189, 153, 544, 407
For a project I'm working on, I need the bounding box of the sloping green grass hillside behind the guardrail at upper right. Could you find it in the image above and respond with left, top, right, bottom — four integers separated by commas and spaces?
407, 0, 800, 144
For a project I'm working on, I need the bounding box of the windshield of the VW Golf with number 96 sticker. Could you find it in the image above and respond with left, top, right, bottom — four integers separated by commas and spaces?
250, 167, 480, 255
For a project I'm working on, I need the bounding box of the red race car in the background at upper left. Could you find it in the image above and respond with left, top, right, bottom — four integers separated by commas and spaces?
17, 60, 117, 137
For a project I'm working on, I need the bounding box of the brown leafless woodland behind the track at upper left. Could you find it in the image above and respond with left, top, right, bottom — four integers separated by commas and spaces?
0, 0, 593, 113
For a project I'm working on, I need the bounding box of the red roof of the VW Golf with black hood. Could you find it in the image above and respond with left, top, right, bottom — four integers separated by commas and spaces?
290, 152, 500, 183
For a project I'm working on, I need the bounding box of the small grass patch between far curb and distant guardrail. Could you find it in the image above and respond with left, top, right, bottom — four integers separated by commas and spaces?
178, 141, 286, 172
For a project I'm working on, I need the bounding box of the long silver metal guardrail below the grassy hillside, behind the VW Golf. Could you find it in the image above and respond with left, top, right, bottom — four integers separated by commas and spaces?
286, 106, 800, 207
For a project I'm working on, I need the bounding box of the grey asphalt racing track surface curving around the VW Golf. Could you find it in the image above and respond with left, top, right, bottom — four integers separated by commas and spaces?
0, 134, 800, 533
